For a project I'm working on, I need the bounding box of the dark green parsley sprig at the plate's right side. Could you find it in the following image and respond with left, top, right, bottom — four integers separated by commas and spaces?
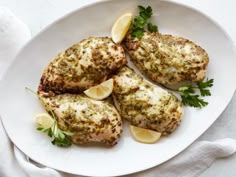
177, 79, 214, 108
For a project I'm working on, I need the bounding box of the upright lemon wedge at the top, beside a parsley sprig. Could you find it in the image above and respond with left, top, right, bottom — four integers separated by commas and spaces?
111, 13, 133, 43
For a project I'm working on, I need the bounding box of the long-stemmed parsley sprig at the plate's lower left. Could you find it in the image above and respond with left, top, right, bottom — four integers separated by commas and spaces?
25, 87, 73, 147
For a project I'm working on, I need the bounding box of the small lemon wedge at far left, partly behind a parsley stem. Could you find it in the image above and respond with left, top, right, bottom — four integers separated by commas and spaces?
34, 113, 54, 128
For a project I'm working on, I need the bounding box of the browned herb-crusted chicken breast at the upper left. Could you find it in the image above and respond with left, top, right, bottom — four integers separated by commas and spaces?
39, 37, 127, 93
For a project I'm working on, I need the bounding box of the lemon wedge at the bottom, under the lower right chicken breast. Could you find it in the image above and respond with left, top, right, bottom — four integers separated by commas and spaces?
130, 125, 161, 144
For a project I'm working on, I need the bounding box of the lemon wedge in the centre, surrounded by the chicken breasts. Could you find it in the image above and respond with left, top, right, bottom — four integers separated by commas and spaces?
84, 79, 113, 100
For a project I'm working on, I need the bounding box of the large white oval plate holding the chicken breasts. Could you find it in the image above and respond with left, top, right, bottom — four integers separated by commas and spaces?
0, 0, 236, 176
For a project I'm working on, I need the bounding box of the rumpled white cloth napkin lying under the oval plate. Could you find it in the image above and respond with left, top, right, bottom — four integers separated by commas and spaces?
0, 7, 236, 177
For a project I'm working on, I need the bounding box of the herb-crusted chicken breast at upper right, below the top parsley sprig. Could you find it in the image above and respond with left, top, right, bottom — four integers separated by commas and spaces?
123, 32, 209, 85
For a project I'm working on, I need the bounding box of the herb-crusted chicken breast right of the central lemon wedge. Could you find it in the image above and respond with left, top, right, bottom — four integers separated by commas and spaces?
113, 66, 183, 135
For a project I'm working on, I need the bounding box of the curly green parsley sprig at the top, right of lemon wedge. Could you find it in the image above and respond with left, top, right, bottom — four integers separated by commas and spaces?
130, 5, 158, 38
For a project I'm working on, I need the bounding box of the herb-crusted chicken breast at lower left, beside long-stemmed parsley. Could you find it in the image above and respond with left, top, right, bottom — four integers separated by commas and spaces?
38, 91, 122, 145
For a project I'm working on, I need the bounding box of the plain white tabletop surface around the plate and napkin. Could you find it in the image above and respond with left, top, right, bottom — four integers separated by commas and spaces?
0, 0, 236, 177
